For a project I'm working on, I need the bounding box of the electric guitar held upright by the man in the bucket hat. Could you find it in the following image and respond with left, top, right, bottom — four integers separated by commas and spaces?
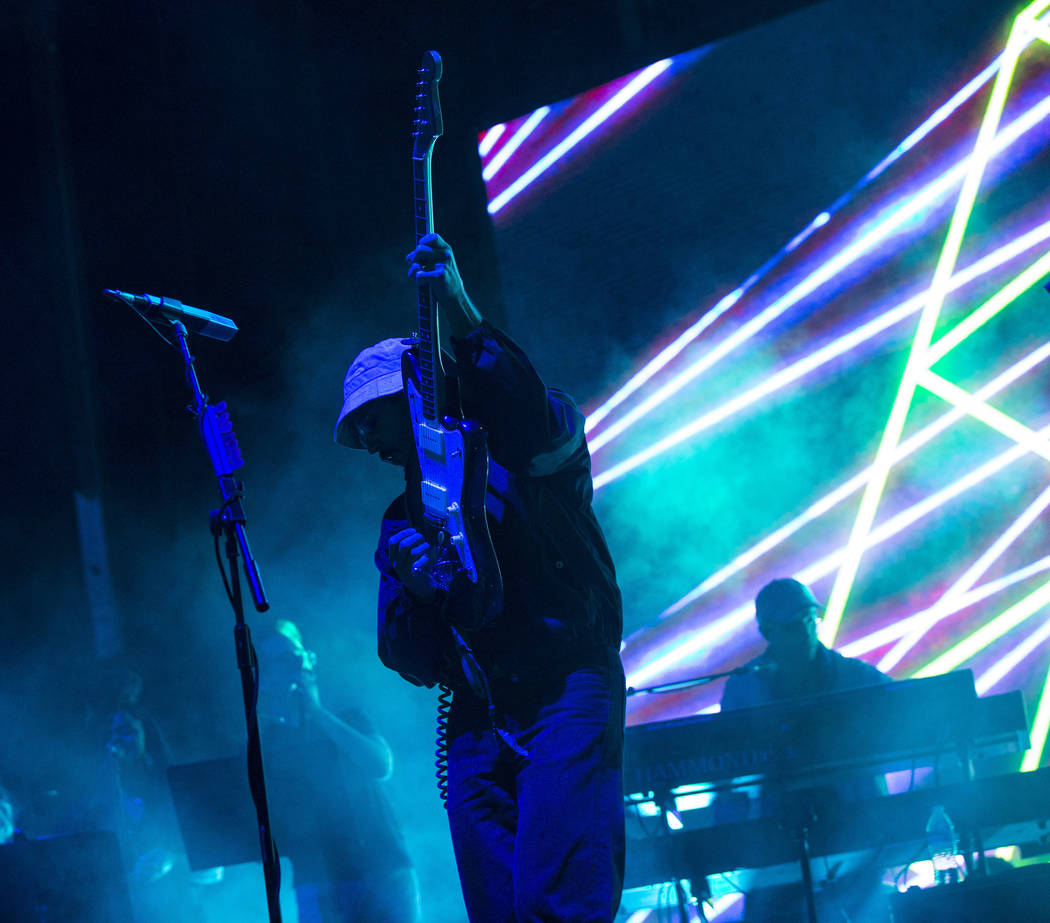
402, 51, 503, 631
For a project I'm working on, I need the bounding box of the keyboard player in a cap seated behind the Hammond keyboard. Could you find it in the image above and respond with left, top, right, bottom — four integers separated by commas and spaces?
715, 579, 890, 923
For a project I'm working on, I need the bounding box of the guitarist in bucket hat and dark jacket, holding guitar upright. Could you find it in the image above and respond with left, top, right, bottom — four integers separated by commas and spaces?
335, 234, 624, 923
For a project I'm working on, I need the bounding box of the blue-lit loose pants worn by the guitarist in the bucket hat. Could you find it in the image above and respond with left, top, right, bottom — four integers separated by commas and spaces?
448, 650, 624, 923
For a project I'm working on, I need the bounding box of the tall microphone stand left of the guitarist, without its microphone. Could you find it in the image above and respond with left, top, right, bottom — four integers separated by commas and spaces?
171, 320, 281, 923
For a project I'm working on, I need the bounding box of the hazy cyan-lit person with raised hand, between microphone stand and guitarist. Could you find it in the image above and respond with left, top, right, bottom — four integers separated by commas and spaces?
255, 621, 420, 923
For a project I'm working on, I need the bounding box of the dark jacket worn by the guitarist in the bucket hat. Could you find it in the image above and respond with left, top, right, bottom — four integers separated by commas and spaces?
376, 323, 623, 686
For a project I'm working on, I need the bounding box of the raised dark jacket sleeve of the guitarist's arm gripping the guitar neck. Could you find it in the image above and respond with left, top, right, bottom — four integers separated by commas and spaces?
454, 321, 586, 477
